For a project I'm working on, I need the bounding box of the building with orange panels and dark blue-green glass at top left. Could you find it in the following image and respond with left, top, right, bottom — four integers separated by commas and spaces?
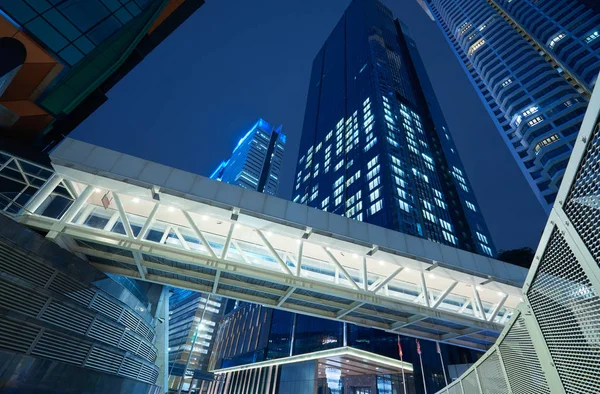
0, 0, 204, 151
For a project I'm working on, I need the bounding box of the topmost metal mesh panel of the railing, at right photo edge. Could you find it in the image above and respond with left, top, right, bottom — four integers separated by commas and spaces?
563, 118, 600, 262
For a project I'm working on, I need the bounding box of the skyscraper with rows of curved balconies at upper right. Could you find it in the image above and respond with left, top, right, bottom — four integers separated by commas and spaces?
418, 0, 600, 212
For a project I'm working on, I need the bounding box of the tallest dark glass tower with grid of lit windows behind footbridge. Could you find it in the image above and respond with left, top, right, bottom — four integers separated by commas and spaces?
294, 0, 495, 256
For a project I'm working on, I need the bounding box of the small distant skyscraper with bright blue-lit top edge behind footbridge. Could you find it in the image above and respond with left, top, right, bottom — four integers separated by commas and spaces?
210, 119, 286, 196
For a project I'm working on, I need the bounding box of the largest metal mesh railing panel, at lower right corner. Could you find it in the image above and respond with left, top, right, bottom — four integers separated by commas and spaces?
528, 230, 600, 393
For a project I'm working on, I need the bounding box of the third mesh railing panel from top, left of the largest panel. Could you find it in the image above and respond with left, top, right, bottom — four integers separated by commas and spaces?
498, 316, 550, 394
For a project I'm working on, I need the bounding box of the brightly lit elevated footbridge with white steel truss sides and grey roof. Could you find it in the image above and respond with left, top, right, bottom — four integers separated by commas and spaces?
0, 139, 526, 350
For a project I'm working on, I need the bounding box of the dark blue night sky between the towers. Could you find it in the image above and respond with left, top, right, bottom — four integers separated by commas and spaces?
72, 0, 546, 249
